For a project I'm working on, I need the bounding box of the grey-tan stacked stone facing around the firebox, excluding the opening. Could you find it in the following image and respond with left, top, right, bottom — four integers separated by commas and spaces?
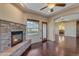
0, 20, 26, 52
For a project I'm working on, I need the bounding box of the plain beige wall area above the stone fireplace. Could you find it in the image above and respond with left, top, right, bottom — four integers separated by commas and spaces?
0, 3, 24, 24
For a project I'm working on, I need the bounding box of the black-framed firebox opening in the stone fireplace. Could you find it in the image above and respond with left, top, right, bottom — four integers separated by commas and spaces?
11, 31, 23, 47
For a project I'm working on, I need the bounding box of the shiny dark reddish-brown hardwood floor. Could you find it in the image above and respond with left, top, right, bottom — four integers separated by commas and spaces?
22, 35, 79, 56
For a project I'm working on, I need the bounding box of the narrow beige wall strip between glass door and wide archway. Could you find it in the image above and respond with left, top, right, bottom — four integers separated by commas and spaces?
48, 18, 55, 41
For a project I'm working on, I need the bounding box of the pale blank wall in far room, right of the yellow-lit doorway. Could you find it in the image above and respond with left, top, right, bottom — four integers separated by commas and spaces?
64, 21, 76, 37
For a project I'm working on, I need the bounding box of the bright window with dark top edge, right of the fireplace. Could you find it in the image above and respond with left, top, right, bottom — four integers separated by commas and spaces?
27, 20, 39, 34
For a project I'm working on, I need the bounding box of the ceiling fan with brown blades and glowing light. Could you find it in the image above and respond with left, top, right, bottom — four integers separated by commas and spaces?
40, 3, 66, 12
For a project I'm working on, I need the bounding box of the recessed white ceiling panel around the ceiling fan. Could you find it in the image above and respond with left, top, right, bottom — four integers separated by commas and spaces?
22, 3, 74, 17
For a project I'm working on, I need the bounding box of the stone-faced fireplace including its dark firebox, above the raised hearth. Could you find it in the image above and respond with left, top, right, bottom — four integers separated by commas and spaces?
0, 20, 26, 52
